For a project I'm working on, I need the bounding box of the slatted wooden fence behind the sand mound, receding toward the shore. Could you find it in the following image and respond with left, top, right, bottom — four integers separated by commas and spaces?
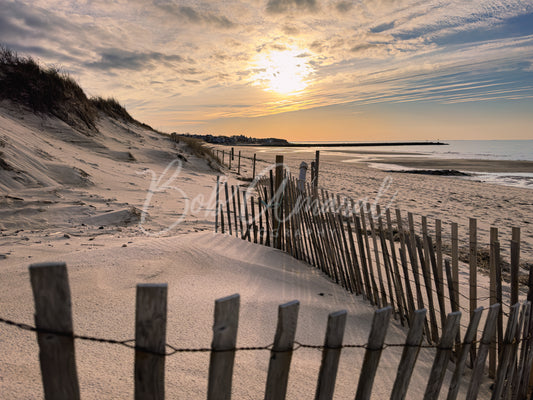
215, 156, 533, 390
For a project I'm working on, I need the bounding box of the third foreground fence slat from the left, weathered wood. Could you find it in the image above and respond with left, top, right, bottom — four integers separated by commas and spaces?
207, 294, 240, 400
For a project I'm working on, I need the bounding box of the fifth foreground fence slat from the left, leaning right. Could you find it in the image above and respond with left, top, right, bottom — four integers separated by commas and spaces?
315, 310, 347, 400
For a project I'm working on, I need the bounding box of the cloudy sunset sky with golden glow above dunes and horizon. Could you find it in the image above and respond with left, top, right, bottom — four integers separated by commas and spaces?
0, 0, 533, 141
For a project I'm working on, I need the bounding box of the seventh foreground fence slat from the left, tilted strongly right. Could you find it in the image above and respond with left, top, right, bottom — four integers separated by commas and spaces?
390, 309, 427, 400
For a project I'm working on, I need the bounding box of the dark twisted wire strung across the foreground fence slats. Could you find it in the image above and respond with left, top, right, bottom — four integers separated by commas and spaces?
0, 317, 531, 357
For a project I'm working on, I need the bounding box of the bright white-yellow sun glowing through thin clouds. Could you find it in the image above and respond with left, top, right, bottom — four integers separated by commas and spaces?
253, 48, 313, 95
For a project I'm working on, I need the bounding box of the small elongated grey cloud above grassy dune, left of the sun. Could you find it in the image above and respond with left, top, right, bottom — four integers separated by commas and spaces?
86, 48, 186, 71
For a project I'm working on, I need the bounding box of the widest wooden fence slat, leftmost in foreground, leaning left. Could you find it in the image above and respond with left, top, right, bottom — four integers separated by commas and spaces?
29, 263, 80, 400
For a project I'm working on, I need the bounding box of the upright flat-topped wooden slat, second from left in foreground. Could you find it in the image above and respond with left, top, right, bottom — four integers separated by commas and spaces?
135, 283, 167, 400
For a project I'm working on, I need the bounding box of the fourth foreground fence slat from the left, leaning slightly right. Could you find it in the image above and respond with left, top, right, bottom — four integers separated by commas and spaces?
265, 300, 300, 400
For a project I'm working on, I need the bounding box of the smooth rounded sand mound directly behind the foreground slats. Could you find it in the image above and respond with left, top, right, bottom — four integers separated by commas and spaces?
0, 232, 487, 399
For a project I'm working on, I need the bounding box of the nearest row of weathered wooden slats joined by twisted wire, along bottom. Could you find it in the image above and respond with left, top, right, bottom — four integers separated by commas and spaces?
16, 263, 533, 400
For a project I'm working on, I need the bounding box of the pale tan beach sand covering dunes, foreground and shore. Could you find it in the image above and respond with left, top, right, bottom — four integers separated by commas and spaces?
0, 104, 533, 399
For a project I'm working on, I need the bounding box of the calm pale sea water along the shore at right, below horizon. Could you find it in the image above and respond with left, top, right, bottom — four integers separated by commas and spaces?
290, 140, 533, 189
